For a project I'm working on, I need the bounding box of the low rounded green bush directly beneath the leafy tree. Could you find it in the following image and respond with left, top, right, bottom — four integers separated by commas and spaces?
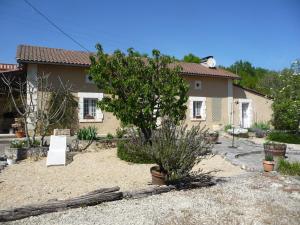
117, 141, 154, 164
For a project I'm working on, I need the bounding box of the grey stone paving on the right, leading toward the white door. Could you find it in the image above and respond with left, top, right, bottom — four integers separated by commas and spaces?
213, 137, 300, 171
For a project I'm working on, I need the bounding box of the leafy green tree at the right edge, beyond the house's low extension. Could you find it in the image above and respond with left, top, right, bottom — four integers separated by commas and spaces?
272, 69, 300, 132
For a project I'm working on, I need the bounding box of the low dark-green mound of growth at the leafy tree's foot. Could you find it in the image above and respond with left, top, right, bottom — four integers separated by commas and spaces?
117, 141, 154, 164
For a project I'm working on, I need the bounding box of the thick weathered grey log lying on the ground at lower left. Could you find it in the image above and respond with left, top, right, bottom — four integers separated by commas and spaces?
0, 187, 123, 222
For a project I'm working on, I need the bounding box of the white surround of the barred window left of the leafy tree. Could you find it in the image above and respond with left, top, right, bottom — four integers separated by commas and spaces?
78, 92, 103, 123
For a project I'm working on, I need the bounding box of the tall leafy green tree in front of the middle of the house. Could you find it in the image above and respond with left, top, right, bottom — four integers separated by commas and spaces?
89, 44, 188, 142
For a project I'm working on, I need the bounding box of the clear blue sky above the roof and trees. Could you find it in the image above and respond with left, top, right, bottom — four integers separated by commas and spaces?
0, 0, 300, 70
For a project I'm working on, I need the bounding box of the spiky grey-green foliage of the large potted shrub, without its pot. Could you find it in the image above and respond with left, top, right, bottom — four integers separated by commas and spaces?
147, 121, 212, 182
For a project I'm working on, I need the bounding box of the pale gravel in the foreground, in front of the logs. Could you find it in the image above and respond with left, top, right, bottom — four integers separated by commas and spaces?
6, 173, 300, 225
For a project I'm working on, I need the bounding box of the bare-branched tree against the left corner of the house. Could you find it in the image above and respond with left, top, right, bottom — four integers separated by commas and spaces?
1, 74, 71, 146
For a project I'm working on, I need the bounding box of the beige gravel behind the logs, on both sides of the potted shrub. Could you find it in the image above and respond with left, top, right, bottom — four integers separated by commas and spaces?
0, 149, 243, 209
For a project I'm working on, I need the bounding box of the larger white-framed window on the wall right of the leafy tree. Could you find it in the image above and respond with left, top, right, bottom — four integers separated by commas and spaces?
189, 96, 206, 120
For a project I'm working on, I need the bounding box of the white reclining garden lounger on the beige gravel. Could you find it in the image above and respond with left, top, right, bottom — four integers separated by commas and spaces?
47, 135, 67, 166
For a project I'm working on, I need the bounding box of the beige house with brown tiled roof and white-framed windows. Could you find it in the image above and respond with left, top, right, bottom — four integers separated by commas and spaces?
12, 45, 272, 134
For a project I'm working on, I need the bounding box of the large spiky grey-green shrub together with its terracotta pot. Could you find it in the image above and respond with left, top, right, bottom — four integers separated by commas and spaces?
127, 121, 212, 185
